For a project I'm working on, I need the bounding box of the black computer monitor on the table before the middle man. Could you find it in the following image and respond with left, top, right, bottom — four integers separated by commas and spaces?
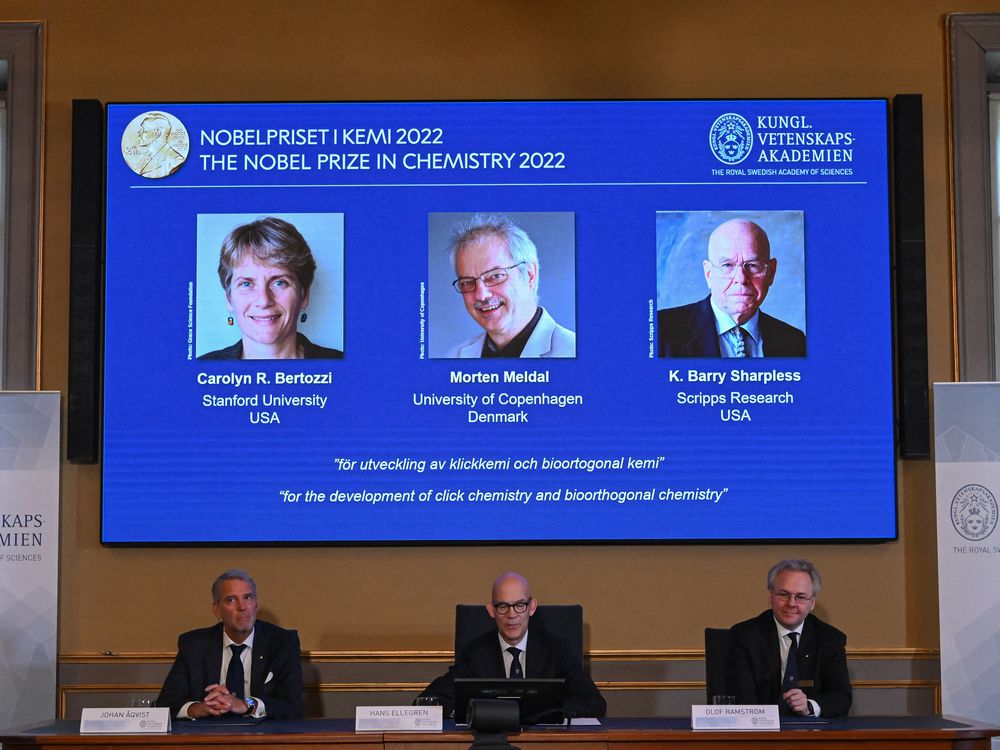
455, 677, 566, 726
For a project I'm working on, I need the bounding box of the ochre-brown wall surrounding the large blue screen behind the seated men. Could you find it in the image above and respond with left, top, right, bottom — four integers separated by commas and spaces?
0, 0, 976, 655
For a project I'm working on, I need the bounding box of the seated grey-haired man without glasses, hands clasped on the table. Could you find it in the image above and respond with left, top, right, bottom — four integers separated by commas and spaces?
156, 569, 302, 719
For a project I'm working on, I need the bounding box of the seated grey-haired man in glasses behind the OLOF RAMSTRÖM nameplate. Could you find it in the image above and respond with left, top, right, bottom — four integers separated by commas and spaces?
726, 560, 851, 716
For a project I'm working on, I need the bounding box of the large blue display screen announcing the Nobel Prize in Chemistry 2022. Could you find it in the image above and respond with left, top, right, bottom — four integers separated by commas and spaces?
102, 100, 896, 544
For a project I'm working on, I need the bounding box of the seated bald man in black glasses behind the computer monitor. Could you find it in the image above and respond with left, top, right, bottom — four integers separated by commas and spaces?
420, 573, 608, 716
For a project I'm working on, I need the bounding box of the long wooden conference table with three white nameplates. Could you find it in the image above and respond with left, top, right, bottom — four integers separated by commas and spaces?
0, 716, 1000, 750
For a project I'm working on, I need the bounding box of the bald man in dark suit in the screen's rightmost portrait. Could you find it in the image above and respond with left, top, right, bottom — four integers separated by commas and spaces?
657, 219, 806, 357
